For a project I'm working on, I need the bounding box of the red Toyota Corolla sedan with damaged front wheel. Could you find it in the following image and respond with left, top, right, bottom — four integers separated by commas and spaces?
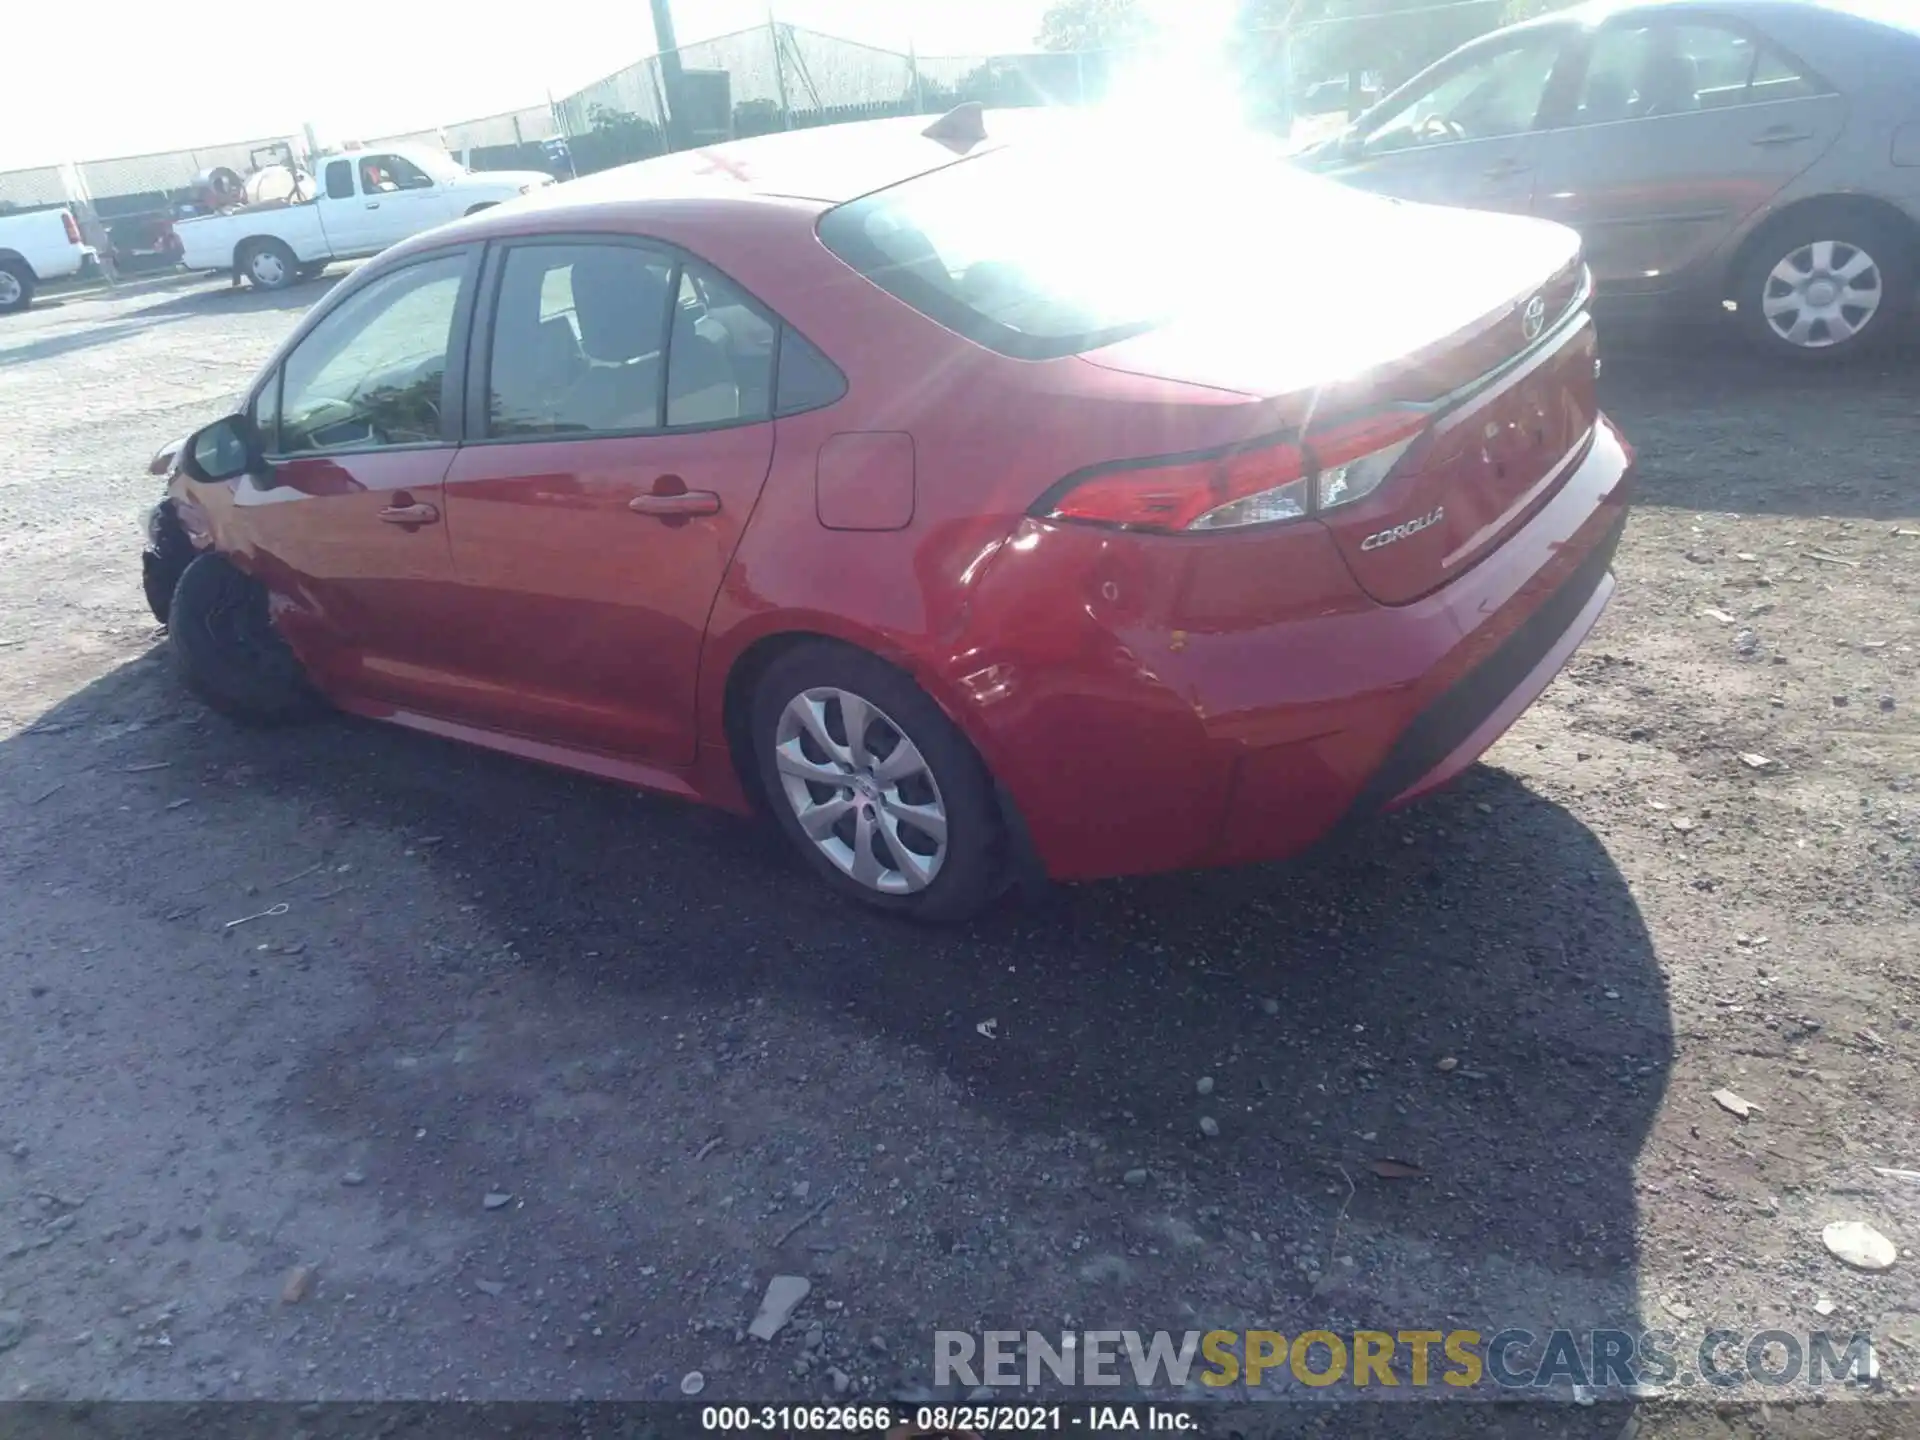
146, 111, 1632, 920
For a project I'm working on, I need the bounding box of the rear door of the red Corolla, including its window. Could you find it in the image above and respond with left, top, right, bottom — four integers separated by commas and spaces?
447, 240, 778, 764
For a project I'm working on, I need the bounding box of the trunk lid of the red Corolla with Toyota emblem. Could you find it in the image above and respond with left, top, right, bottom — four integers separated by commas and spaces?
1085, 192, 1597, 605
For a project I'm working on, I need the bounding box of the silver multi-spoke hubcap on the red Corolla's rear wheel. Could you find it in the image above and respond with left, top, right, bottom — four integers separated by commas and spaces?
774, 685, 947, 895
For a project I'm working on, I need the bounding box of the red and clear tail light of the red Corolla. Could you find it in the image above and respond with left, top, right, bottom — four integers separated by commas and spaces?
1035, 407, 1428, 534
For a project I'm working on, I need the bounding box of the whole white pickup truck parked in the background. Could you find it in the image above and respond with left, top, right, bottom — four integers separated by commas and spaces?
173, 146, 553, 290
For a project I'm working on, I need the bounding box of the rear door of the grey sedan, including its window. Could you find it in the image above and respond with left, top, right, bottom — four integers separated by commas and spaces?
1534, 12, 1847, 292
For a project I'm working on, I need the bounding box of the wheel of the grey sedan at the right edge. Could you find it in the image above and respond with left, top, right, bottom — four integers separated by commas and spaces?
1734, 205, 1916, 365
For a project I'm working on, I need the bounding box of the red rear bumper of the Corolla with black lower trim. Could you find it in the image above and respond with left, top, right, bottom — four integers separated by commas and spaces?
973, 419, 1634, 879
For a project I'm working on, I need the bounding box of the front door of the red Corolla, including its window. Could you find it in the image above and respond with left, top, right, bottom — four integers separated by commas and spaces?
232, 255, 480, 707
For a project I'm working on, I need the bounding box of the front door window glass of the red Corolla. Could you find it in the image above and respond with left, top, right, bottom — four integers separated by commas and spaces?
278, 255, 467, 455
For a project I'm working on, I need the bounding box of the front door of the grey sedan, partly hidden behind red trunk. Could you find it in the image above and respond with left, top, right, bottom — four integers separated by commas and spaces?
1331, 25, 1578, 213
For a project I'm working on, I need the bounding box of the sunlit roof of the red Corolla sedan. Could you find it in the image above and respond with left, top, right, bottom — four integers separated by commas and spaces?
515, 109, 1048, 215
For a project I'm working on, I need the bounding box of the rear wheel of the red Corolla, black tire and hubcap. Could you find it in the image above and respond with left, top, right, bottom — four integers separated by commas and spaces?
749, 641, 1004, 924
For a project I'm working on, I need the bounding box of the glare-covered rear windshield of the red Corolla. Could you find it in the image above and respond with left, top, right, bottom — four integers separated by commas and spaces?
820, 134, 1290, 359
